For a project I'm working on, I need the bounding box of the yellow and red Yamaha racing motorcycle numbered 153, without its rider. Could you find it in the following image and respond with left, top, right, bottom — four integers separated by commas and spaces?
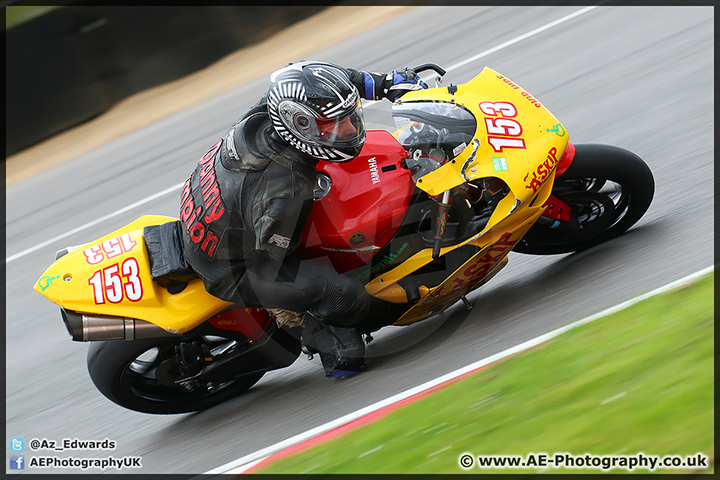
35, 64, 654, 414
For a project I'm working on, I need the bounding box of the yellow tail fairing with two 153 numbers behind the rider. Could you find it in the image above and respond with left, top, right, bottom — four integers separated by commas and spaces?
35, 216, 231, 333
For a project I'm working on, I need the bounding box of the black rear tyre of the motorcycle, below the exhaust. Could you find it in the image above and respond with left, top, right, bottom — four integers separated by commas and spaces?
87, 337, 263, 414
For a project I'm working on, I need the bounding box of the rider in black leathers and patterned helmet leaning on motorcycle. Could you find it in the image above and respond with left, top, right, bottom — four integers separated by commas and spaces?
180, 61, 427, 375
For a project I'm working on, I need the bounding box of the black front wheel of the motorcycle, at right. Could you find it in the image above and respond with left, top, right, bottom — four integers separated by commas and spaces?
513, 144, 655, 255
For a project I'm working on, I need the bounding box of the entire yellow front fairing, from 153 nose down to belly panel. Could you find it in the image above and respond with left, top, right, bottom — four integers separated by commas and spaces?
372, 68, 568, 325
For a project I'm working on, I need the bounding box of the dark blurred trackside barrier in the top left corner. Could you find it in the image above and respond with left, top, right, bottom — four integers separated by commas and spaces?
3, 2, 333, 155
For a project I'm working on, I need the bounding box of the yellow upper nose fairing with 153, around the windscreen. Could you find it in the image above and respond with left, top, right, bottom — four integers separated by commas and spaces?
399, 68, 568, 203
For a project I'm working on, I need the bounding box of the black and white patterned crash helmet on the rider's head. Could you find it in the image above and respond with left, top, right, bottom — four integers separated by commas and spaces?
267, 62, 365, 162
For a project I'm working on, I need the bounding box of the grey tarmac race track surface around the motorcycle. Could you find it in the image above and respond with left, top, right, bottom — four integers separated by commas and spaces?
6, 7, 714, 473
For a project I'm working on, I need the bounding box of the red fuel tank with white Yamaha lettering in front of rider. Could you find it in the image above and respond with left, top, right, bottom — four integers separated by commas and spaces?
297, 130, 415, 272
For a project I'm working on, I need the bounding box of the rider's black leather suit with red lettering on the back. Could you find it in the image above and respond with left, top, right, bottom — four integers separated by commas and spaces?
180, 69, 382, 327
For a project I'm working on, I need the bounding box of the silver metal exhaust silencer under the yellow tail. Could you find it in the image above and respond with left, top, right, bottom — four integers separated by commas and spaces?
60, 308, 179, 342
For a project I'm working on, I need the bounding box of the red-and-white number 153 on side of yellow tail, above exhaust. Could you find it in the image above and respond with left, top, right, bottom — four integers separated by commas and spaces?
88, 257, 143, 305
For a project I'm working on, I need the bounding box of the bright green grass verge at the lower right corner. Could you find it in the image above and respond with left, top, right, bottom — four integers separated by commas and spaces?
259, 275, 714, 474
